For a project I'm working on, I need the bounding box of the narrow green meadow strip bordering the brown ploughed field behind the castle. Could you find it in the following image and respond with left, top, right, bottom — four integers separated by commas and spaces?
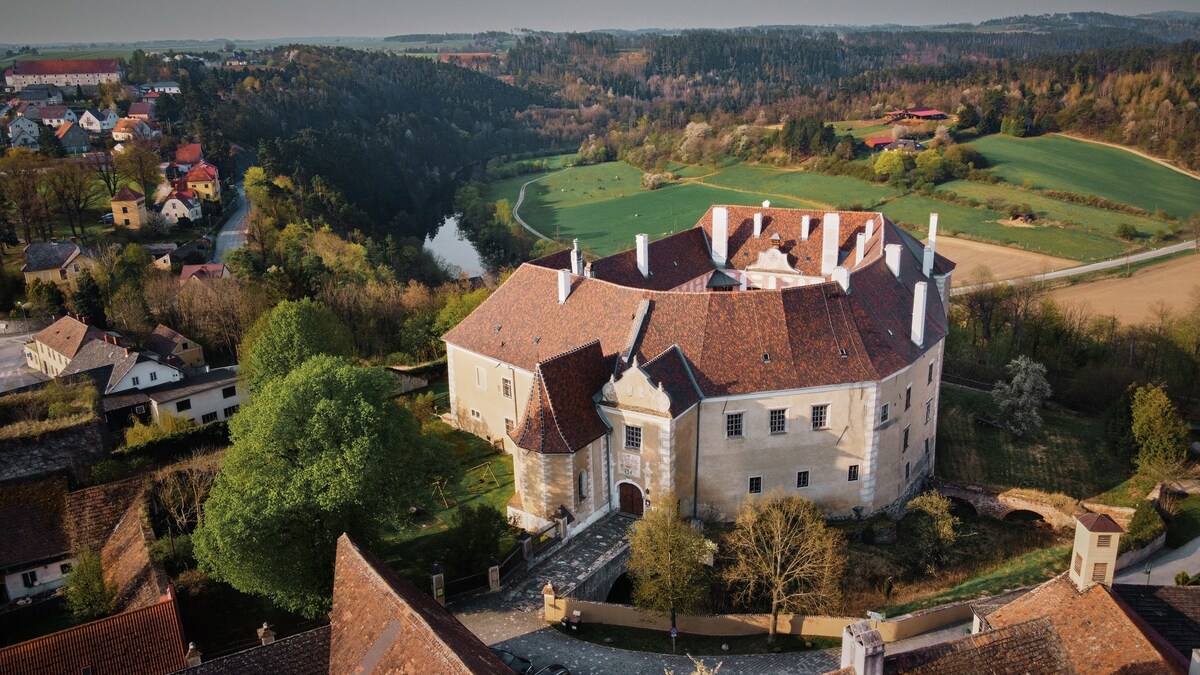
881, 195, 1126, 262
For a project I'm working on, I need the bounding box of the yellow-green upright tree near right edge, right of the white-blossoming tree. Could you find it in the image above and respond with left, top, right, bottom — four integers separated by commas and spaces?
1133, 384, 1188, 480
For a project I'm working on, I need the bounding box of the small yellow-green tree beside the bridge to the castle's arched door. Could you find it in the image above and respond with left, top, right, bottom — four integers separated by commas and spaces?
629, 494, 715, 628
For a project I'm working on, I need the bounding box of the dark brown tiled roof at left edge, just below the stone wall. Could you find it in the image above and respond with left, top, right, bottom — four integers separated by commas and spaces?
0, 476, 70, 572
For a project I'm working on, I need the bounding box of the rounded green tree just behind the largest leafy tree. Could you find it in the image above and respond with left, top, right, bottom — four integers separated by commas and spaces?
241, 298, 350, 392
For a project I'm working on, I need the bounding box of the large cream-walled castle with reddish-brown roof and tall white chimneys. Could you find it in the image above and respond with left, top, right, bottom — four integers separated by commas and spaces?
443, 203, 954, 532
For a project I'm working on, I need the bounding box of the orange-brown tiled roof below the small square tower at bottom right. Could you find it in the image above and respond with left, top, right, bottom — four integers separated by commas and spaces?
988, 574, 1187, 675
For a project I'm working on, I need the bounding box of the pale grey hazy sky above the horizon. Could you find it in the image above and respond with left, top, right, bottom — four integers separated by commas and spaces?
0, 0, 1200, 43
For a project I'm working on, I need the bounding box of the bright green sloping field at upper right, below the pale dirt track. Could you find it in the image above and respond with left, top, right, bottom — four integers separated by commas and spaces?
972, 135, 1200, 219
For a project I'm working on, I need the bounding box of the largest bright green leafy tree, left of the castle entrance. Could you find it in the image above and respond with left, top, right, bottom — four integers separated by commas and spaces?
192, 356, 455, 619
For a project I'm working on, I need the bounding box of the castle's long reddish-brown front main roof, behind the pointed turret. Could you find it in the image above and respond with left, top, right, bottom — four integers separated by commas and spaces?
444, 209, 948, 396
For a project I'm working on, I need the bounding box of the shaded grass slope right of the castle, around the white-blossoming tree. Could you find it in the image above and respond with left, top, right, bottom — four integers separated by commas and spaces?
937, 387, 1130, 500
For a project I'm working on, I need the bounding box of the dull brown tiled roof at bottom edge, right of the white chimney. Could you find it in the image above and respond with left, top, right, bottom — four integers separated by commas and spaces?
883, 617, 1082, 675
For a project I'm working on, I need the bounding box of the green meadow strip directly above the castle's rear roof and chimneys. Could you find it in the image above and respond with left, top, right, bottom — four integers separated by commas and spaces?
703, 165, 896, 209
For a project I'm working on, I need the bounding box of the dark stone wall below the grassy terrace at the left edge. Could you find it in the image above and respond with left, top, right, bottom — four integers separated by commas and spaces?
0, 420, 107, 484
